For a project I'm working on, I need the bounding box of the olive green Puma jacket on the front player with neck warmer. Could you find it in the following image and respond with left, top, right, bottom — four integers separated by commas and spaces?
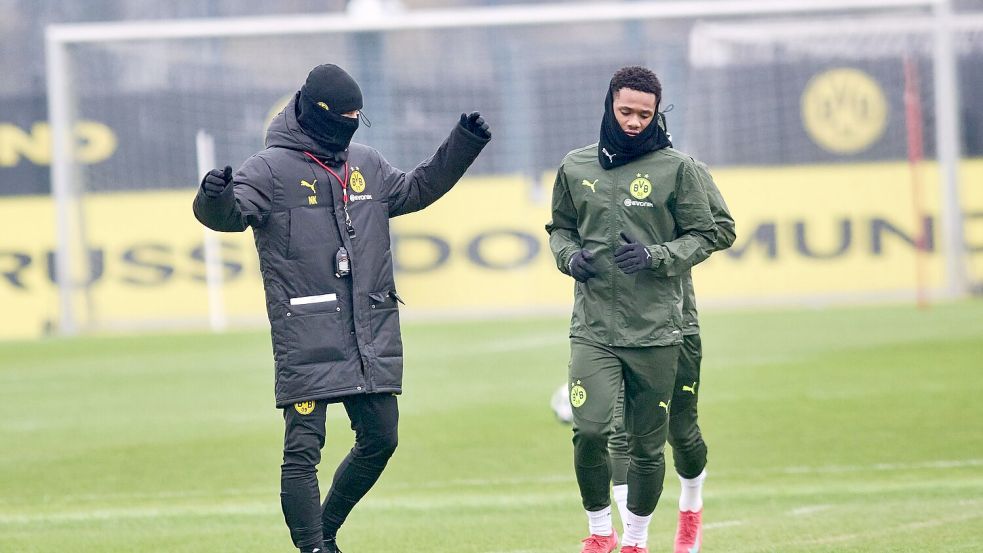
546, 144, 716, 347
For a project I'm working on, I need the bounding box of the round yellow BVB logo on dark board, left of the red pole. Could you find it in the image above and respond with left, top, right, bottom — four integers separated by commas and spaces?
802, 68, 888, 154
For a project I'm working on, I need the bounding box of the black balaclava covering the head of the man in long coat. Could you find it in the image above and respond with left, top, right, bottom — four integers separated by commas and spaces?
297, 63, 362, 152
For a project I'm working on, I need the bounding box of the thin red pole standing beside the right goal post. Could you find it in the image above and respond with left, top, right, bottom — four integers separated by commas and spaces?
904, 55, 928, 309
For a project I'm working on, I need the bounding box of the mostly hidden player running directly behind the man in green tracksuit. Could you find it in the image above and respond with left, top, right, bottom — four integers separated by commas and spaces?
608, 156, 736, 553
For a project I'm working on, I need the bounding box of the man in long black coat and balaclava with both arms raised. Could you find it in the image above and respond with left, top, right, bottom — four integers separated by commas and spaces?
194, 64, 491, 553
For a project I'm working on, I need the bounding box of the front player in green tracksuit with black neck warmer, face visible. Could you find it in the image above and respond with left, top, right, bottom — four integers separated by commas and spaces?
546, 67, 716, 553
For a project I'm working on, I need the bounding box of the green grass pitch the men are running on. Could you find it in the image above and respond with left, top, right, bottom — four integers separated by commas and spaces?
0, 300, 983, 553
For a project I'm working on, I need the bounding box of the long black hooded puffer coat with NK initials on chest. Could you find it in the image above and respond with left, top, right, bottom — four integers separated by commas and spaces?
194, 97, 488, 407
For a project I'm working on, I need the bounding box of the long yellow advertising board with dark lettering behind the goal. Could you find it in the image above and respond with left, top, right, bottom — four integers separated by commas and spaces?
0, 161, 983, 339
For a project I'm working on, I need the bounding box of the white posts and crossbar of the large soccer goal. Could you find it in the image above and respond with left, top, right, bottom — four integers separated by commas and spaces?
45, 0, 960, 335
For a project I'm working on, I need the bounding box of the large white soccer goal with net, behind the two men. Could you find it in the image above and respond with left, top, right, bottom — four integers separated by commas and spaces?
46, 0, 968, 334
